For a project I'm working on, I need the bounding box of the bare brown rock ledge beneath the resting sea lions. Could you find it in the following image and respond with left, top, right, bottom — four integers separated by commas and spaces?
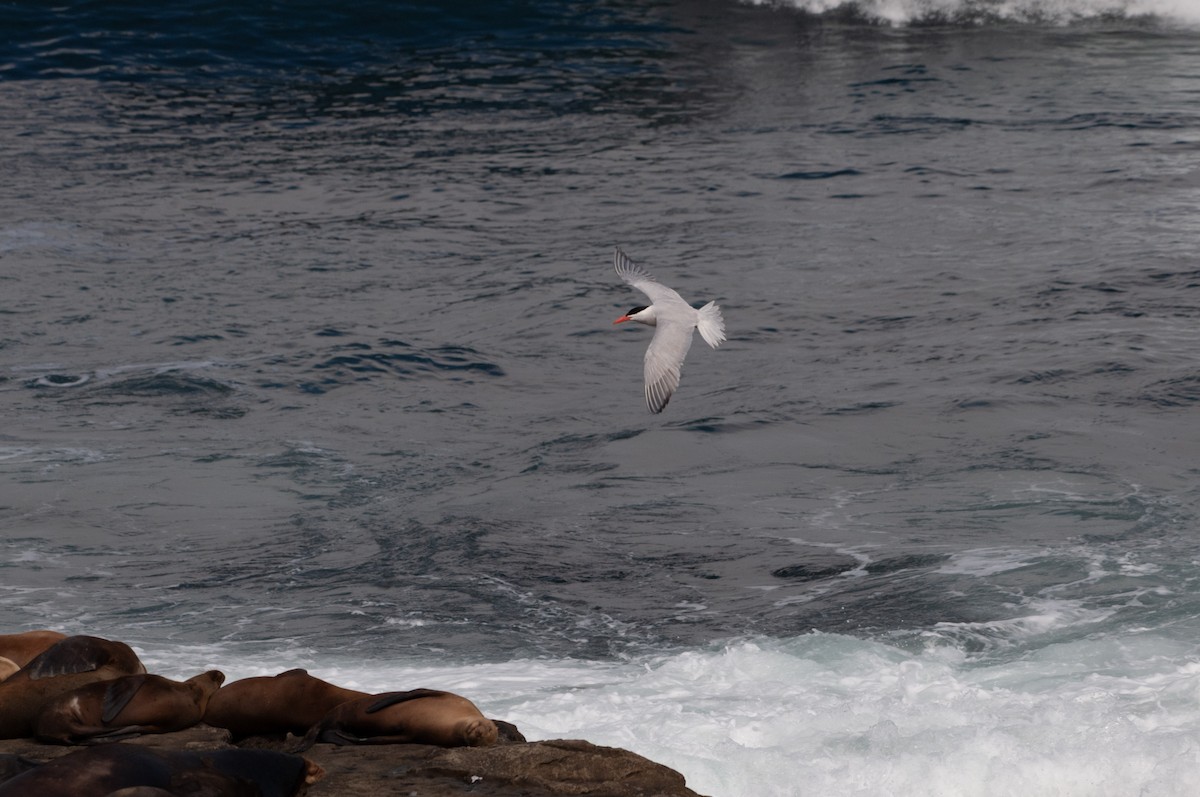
0, 725, 700, 797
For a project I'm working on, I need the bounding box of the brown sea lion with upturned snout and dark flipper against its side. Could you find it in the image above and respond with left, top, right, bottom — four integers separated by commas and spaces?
34, 670, 224, 744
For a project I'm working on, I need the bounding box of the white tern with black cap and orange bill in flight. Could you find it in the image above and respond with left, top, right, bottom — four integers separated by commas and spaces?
612, 248, 725, 413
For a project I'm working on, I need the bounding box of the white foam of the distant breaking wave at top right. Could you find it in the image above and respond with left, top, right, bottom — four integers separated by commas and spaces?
750, 0, 1200, 25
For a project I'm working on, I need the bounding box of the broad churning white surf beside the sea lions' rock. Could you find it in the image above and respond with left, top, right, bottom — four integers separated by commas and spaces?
136, 634, 1200, 797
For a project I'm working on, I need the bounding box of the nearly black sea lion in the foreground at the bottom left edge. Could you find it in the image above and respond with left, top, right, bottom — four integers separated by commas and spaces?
0, 743, 324, 797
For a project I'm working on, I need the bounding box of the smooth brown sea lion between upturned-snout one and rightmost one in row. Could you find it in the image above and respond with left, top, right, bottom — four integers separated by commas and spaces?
204, 670, 370, 739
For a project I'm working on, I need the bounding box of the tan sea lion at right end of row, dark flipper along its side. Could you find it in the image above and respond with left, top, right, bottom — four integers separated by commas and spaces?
292, 689, 498, 753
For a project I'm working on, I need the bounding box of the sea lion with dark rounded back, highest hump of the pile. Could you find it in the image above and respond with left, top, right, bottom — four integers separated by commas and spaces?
0, 636, 145, 739
